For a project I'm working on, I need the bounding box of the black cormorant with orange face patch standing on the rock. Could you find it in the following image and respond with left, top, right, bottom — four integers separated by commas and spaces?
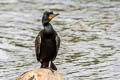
35, 11, 60, 70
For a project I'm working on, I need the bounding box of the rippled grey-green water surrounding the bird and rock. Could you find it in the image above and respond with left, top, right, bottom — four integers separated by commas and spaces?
0, 0, 120, 80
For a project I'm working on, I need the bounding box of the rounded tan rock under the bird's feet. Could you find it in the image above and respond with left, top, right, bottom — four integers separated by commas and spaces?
13, 68, 64, 80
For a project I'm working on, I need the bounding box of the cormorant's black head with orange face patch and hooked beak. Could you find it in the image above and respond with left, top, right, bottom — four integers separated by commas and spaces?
42, 11, 59, 24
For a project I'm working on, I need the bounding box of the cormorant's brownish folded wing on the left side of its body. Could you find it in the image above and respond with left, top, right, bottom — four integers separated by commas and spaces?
35, 34, 41, 61
